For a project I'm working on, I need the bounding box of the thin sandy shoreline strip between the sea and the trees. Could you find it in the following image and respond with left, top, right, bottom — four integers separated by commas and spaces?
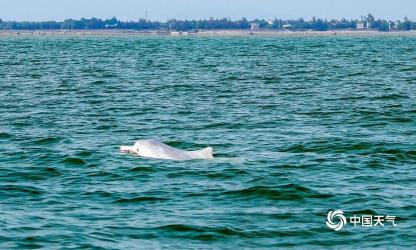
0, 29, 416, 36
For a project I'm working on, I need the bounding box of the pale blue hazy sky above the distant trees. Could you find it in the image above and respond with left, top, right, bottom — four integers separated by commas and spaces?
0, 0, 416, 21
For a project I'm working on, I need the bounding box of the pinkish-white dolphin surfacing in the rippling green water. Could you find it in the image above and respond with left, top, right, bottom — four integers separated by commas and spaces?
120, 139, 214, 161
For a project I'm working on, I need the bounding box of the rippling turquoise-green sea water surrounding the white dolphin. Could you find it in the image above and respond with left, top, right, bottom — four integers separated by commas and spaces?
0, 36, 416, 249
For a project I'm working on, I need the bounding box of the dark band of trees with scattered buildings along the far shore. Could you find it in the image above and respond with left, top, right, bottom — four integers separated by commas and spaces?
0, 14, 416, 31
